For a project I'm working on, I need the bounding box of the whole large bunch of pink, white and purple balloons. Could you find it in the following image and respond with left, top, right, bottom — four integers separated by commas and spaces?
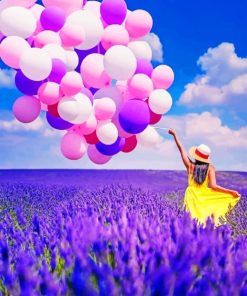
0, 0, 174, 164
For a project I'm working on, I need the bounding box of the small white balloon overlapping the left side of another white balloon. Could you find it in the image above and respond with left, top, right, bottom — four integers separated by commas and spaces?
57, 97, 80, 122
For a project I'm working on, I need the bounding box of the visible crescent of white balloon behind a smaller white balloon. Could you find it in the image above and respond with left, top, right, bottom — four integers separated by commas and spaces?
70, 93, 93, 124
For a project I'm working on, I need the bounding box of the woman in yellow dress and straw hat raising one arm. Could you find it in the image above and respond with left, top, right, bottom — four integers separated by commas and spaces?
169, 129, 240, 225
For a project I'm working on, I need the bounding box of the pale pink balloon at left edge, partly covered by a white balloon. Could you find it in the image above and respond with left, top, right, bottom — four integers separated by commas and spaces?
0, 36, 30, 69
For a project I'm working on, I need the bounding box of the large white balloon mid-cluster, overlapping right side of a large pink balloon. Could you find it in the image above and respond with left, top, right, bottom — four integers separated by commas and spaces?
104, 45, 137, 80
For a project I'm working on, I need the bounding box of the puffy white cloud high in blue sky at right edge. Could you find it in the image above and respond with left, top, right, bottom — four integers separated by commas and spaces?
179, 42, 247, 108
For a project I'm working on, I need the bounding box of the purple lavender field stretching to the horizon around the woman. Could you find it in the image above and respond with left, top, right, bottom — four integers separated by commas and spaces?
0, 170, 247, 296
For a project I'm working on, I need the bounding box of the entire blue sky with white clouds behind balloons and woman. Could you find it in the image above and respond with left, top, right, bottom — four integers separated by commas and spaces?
0, 0, 247, 171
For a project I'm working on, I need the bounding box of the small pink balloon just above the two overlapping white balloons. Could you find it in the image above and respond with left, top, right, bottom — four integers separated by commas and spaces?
61, 71, 83, 96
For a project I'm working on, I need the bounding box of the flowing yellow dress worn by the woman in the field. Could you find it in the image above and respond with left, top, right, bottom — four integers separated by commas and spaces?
184, 164, 240, 226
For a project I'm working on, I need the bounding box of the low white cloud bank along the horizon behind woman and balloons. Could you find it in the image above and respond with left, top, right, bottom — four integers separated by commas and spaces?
0, 112, 247, 171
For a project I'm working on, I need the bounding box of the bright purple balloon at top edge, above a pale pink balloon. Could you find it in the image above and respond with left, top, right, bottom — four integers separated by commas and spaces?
100, 0, 127, 25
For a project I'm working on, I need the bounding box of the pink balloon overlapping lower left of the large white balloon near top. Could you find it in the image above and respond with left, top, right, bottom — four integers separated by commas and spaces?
59, 22, 86, 47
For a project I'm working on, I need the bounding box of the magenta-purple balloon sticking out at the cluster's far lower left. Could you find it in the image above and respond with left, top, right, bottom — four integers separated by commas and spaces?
13, 96, 41, 123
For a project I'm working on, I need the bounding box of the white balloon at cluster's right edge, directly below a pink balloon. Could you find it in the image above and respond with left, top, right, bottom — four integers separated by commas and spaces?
148, 89, 172, 114
